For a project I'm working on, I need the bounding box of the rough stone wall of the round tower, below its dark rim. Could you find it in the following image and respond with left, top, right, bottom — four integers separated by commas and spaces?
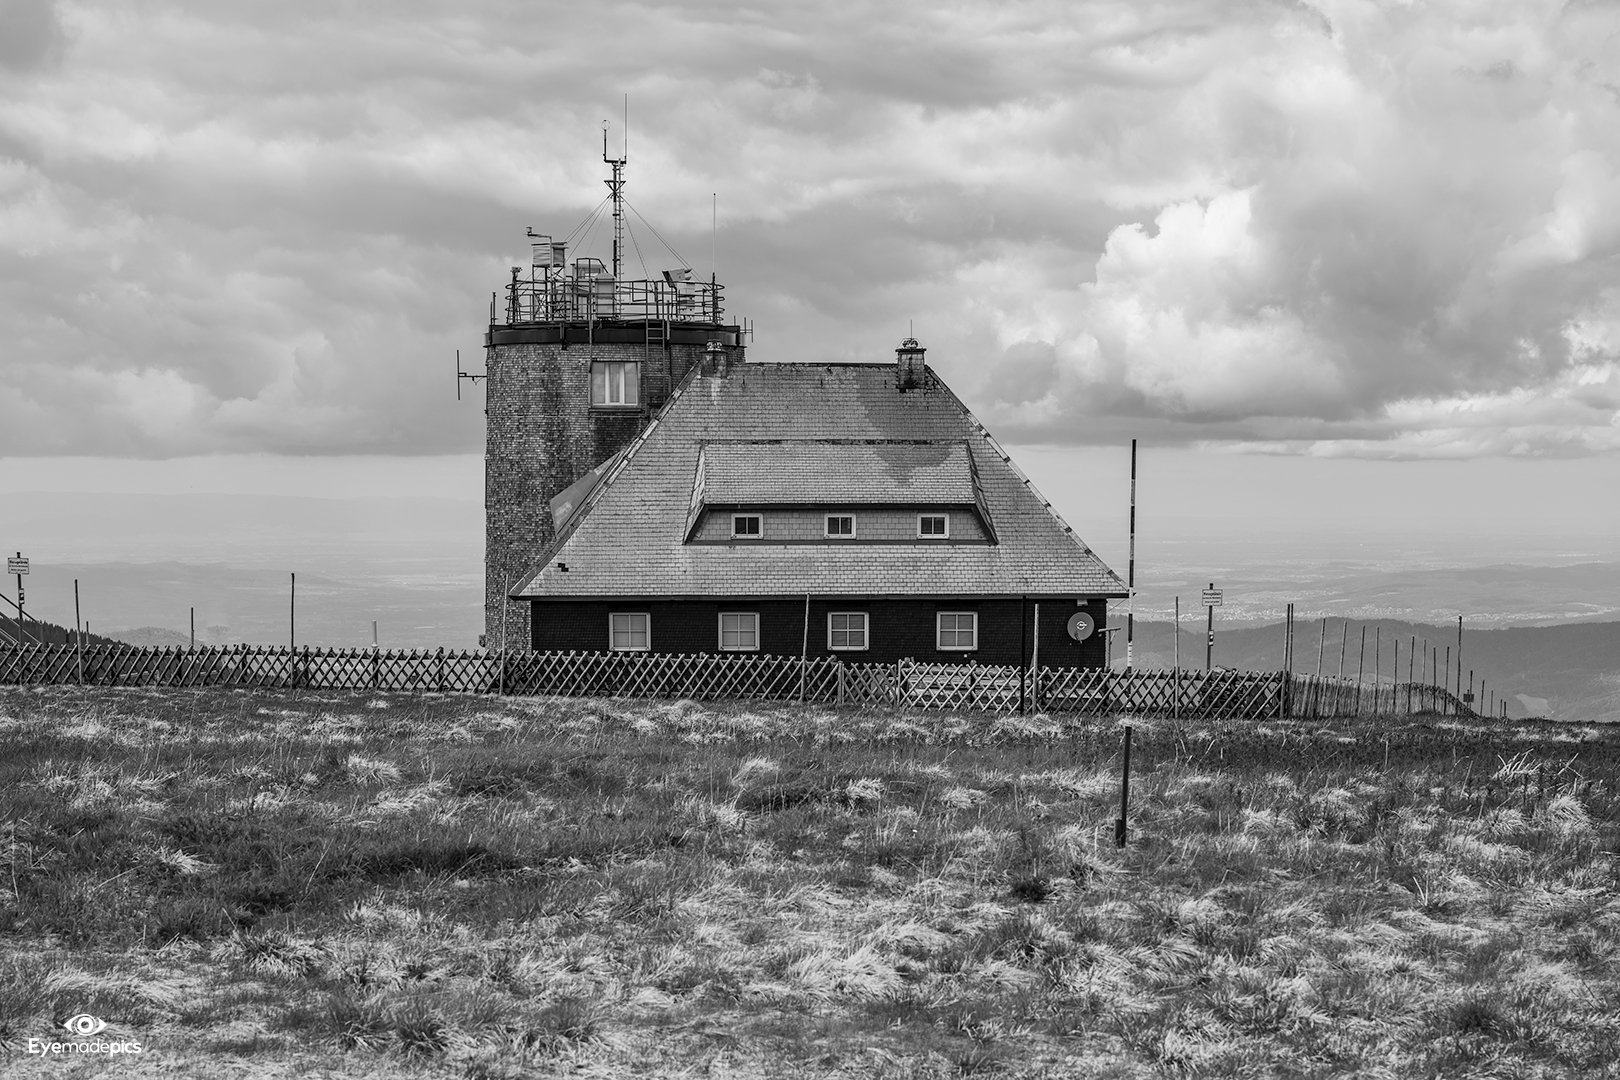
484, 342, 742, 651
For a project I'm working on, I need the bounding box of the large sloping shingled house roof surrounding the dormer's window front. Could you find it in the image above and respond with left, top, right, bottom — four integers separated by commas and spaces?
512, 363, 1124, 599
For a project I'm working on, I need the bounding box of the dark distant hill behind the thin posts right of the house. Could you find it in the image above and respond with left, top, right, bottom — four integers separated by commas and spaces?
1110, 612, 1620, 722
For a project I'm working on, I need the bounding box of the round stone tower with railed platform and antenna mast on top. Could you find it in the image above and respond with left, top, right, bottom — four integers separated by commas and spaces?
484, 144, 748, 651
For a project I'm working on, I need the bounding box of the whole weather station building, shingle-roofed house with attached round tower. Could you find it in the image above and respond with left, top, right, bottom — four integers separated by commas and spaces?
484, 127, 1126, 667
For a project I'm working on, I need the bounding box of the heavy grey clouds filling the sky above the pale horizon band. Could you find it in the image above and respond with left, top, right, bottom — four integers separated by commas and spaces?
0, 0, 1620, 458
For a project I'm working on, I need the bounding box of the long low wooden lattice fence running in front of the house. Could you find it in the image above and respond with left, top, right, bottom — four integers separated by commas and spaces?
0, 644, 1471, 719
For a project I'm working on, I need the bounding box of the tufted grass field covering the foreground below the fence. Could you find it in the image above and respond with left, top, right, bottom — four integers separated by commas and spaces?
0, 688, 1620, 1078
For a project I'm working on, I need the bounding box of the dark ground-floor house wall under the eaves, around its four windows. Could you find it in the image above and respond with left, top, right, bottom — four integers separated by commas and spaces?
530, 596, 1106, 667
